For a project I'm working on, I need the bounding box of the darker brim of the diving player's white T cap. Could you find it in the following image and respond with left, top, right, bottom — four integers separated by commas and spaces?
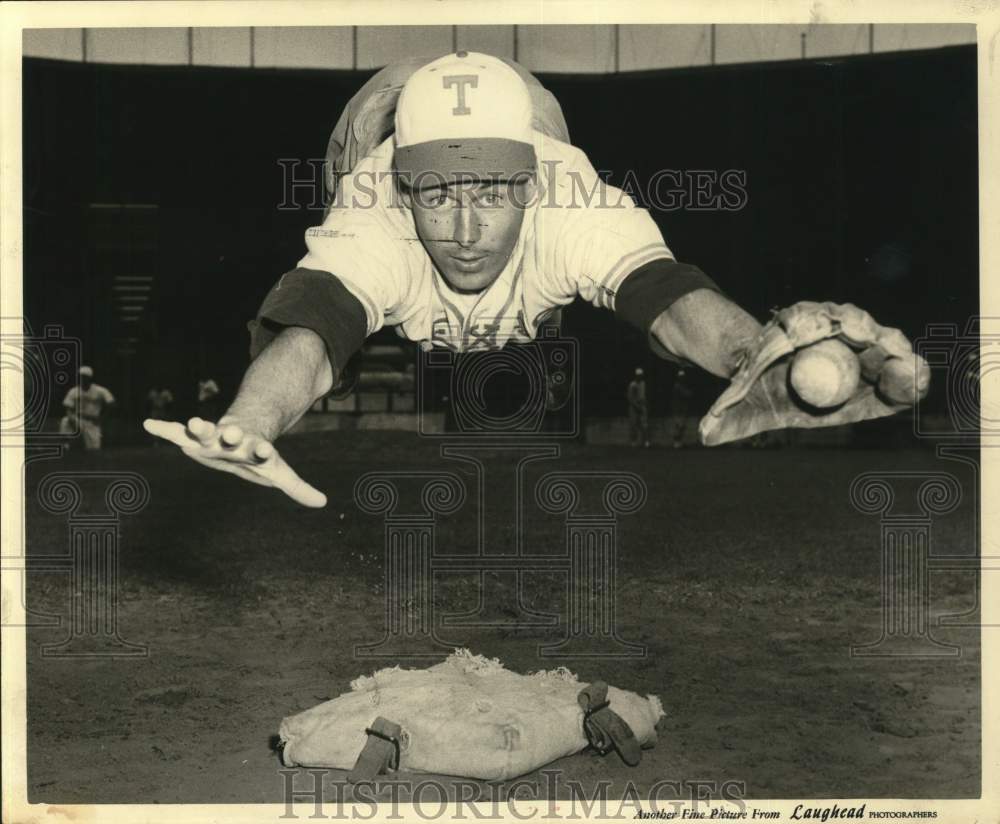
394, 137, 537, 189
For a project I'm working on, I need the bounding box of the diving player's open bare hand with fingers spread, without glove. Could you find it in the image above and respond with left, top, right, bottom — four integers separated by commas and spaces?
142, 418, 326, 507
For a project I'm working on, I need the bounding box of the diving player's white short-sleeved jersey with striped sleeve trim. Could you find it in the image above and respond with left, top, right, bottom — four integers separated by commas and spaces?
294, 132, 673, 352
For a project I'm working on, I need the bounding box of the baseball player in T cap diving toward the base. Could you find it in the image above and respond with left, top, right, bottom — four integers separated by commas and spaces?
146, 51, 928, 507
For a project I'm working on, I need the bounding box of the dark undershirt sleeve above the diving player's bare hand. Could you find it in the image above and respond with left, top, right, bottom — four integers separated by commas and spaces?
247, 269, 368, 383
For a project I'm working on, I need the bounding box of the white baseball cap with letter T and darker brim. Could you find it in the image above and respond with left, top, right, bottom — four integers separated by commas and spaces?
395, 51, 536, 188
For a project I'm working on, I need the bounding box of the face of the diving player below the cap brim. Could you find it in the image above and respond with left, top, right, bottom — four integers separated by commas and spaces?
409, 182, 531, 292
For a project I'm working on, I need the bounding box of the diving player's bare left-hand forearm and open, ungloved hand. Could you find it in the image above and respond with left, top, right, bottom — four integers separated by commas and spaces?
143, 327, 333, 507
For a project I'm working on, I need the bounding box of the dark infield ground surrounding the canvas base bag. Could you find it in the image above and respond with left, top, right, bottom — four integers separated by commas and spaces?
26, 433, 976, 803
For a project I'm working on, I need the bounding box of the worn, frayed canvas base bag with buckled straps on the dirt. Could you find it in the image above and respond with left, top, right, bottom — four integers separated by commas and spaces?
280, 650, 663, 782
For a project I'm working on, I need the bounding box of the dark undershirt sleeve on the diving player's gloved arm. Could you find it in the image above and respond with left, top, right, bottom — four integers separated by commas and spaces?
615, 259, 722, 360
